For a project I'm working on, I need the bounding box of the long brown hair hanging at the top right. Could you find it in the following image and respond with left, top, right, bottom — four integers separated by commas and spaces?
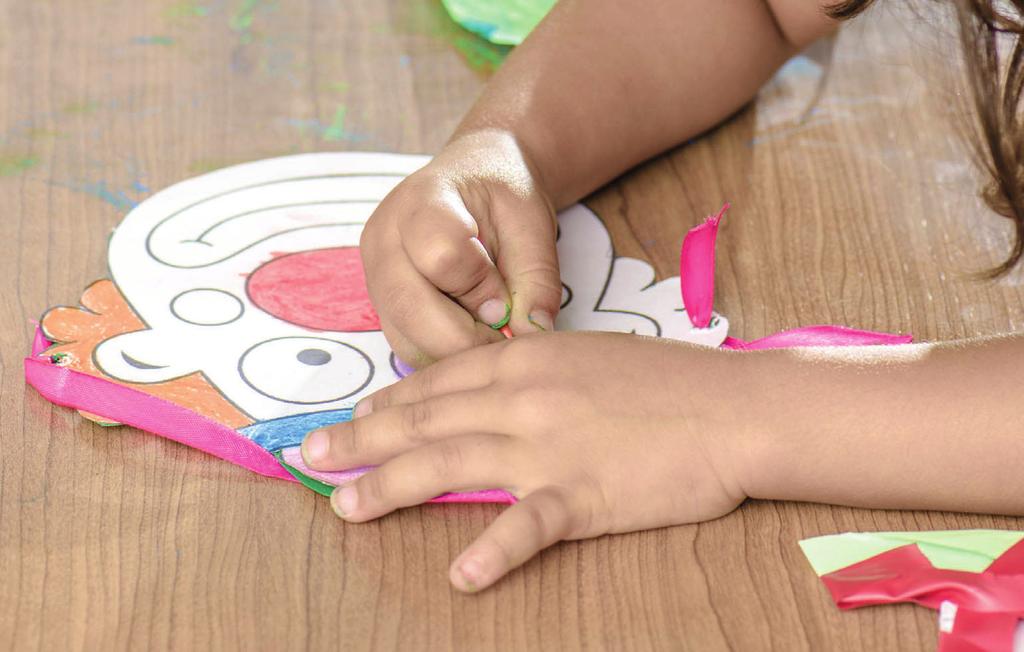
825, 0, 1024, 277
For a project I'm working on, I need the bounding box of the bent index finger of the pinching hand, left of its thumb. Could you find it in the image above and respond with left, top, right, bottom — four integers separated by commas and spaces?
401, 200, 512, 330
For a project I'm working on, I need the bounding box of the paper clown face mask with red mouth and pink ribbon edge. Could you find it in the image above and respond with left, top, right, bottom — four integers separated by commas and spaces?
26, 154, 728, 501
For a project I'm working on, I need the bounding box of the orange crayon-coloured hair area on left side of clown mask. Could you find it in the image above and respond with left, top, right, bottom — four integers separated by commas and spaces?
40, 278, 253, 429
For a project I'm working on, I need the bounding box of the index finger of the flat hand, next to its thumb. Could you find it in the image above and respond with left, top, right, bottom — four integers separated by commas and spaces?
331, 435, 513, 523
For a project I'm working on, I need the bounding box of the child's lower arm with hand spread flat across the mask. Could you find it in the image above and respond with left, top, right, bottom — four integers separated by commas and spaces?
302, 333, 1024, 591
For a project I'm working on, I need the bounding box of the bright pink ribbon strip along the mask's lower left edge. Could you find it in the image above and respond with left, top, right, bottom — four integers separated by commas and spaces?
25, 328, 297, 482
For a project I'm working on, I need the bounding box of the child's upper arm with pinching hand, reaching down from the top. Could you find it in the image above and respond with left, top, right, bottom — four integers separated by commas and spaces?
360, 0, 834, 366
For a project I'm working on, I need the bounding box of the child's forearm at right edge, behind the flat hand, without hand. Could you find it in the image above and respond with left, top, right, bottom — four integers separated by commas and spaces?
746, 337, 1024, 514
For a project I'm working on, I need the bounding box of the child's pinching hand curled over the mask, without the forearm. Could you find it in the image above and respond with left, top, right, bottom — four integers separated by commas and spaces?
359, 131, 561, 366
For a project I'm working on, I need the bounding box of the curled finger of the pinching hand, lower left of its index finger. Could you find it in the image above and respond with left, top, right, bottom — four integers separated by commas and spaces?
364, 241, 503, 358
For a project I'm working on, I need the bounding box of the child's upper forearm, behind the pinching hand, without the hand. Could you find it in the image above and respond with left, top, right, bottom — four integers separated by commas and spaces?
456, 0, 833, 207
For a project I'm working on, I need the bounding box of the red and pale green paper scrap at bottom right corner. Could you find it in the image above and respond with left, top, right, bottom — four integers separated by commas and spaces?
800, 530, 1024, 652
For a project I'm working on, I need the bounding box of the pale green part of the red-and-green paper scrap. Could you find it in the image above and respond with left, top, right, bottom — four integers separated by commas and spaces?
800, 530, 1024, 577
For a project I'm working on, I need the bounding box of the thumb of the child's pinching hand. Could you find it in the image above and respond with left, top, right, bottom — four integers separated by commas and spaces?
495, 202, 562, 335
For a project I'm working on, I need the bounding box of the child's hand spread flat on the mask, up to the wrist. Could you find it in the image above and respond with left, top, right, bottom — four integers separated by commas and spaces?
302, 333, 756, 591
